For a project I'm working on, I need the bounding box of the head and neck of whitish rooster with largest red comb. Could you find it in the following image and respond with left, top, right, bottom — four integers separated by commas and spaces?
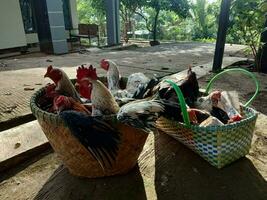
79, 65, 119, 116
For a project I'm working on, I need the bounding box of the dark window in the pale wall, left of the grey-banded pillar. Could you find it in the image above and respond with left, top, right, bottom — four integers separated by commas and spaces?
19, 0, 36, 33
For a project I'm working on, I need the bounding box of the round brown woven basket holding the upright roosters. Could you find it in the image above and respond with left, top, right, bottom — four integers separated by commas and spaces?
30, 78, 151, 178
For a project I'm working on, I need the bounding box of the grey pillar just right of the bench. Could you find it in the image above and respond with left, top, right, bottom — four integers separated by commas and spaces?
106, 0, 120, 46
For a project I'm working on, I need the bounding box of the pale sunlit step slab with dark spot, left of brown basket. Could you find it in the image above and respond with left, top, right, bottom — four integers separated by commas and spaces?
0, 120, 50, 171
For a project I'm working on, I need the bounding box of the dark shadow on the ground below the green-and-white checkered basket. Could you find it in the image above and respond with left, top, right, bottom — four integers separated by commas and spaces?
155, 134, 267, 200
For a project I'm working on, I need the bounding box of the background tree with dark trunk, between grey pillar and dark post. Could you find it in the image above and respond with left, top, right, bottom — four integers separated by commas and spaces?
136, 0, 189, 45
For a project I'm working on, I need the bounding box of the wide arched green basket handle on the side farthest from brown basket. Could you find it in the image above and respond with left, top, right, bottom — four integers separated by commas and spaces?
205, 68, 259, 107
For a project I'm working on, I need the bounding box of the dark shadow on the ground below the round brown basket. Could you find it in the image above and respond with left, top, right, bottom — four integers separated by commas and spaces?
34, 166, 147, 200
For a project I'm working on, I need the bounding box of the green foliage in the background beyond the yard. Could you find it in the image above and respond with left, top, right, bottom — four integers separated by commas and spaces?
77, 0, 267, 62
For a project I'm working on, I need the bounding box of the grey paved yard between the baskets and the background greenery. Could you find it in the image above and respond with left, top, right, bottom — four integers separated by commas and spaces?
0, 42, 246, 72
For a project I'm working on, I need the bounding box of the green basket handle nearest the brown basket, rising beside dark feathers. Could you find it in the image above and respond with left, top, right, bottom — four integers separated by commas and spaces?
164, 79, 191, 127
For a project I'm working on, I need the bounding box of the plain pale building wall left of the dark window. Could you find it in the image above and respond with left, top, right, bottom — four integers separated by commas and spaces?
0, 0, 26, 49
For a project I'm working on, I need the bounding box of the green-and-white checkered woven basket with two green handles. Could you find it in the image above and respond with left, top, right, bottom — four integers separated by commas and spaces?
157, 68, 259, 168
